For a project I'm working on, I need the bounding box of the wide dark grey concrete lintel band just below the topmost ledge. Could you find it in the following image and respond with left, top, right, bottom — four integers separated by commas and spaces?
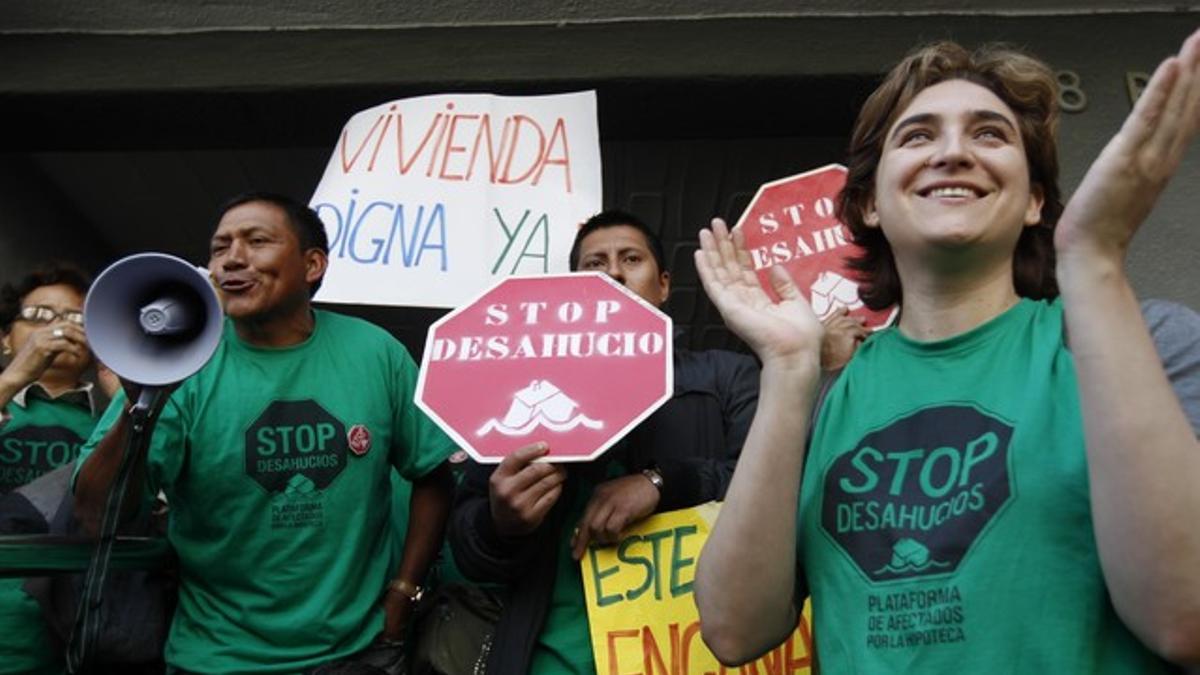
0, 11, 1200, 95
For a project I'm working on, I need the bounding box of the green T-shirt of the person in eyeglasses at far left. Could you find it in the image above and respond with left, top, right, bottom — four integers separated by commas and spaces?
0, 394, 96, 675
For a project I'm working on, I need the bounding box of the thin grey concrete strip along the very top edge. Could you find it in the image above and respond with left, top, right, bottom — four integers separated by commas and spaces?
0, 0, 1200, 32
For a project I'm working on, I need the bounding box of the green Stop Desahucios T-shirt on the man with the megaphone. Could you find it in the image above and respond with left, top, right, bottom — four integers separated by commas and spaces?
84, 311, 452, 673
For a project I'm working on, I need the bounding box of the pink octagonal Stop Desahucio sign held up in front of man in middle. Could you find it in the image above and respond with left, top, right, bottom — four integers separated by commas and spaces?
415, 273, 674, 462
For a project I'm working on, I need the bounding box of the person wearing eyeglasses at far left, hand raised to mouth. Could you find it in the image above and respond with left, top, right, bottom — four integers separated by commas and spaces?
0, 263, 110, 674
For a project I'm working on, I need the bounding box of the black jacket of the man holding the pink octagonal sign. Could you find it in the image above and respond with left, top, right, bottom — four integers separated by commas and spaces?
448, 348, 758, 675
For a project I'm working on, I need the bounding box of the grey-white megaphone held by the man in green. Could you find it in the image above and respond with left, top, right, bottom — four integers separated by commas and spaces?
83, 253, 222, 400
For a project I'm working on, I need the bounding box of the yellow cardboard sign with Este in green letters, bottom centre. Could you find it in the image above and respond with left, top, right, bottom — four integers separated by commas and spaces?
581, 502, 812, 675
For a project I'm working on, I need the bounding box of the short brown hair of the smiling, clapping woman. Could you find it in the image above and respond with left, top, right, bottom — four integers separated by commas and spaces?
838, 42, 1062, 310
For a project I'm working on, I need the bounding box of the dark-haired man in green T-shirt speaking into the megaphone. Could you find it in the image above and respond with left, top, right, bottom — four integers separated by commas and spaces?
76, 193, 454, 673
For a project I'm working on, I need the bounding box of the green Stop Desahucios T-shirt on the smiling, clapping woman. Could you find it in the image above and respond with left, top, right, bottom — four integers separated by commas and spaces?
798, 300, 1164, 674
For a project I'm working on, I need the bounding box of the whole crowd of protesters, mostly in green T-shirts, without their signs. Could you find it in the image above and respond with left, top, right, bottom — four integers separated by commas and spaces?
0, 32, 1200, 675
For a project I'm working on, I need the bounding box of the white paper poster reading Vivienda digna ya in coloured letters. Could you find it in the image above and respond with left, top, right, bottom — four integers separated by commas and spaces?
310, 91, 601, 307
